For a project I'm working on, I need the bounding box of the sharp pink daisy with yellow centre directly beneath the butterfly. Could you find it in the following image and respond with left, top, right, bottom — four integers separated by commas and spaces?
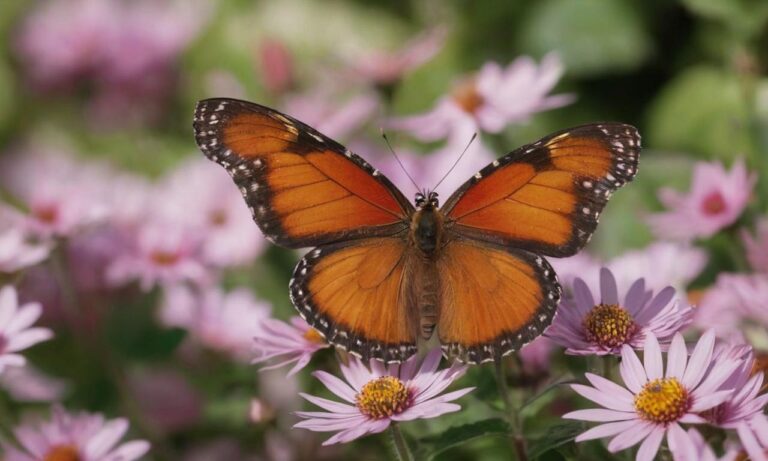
294, 348, 474, 445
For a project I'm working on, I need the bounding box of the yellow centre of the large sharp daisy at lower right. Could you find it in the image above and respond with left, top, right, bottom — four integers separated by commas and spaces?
635, 378, 691, 423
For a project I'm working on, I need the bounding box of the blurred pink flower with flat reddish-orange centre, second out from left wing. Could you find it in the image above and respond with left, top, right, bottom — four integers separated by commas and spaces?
107, 221, 211, 291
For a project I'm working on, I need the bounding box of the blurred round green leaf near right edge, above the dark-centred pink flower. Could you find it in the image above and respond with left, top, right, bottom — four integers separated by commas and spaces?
647, 67, 752, 159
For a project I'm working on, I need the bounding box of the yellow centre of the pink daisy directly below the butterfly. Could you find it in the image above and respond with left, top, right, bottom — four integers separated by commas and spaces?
355, 376, 411, 419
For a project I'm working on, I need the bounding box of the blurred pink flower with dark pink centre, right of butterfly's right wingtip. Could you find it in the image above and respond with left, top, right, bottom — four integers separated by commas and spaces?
648, 160, 757, 240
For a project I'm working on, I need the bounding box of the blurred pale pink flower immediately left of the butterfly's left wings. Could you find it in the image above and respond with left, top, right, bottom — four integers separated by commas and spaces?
159, 156, 265, 267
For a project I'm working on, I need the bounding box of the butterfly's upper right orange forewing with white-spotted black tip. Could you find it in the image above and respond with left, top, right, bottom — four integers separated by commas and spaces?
443, 123, 640, 257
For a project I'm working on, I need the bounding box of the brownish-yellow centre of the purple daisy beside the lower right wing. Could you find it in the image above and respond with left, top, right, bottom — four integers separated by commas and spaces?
584, 304, 637, 348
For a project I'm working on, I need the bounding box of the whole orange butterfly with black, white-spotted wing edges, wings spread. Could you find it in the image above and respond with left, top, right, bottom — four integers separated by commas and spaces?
193, 98, 640, 363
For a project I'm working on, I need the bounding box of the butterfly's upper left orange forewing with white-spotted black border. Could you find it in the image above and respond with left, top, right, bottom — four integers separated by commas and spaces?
193, 99, 413, 248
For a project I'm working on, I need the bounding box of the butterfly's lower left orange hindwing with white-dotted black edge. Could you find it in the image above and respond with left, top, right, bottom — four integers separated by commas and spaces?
290, 238, 418, 362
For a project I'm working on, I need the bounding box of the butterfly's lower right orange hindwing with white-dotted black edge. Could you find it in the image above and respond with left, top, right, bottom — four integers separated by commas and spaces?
437, 240, 561, 363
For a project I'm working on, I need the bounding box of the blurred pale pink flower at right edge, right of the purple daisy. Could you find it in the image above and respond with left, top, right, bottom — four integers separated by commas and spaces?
694, 273, 768, 341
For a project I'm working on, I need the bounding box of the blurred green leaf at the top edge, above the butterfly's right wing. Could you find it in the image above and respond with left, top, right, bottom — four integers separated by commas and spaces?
519, 0, 651, 76
